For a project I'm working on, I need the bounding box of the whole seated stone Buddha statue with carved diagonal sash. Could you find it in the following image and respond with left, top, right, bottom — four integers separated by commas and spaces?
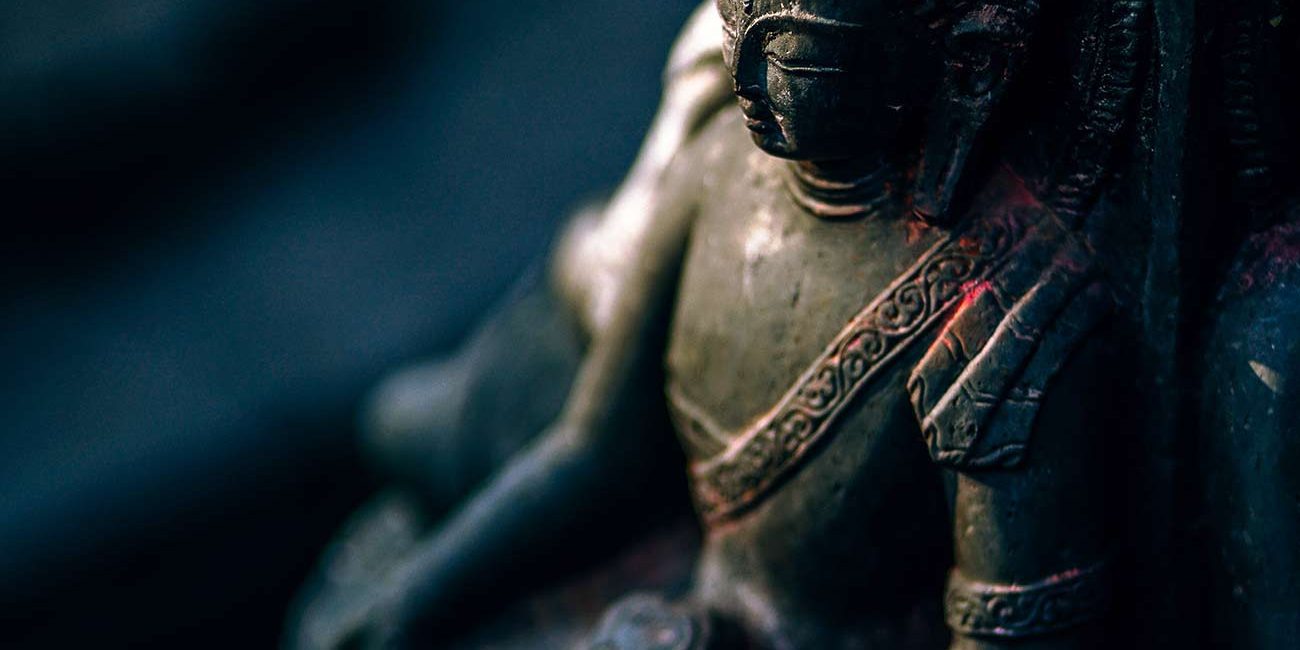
287, 0, 1147, 650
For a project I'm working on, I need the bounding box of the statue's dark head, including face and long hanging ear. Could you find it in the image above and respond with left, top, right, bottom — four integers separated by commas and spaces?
718, 0, 1037, 218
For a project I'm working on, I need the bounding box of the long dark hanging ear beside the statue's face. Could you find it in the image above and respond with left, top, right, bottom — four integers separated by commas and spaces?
913, 1, 1037, 224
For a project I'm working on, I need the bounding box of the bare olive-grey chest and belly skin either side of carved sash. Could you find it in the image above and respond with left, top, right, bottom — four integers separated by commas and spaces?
667, 116, 950, 646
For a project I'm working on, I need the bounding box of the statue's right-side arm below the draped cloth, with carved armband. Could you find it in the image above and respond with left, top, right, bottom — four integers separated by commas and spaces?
945, 330, 1118, 650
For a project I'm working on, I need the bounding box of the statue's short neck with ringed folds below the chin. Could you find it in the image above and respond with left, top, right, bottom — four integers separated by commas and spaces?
785, 157, 901, 218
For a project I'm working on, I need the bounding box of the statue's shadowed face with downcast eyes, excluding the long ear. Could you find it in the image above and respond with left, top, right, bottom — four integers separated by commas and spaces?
718, 0, 943, 161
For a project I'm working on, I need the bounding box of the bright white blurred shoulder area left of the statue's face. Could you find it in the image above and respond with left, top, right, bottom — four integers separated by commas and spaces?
551, 0, 732, 334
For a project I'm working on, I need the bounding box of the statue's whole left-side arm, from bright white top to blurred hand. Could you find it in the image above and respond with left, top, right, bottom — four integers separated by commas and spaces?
289, 5, 731, 647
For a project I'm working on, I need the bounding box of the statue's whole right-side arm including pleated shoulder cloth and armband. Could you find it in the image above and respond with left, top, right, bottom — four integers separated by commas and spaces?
907, 207, 1127, 650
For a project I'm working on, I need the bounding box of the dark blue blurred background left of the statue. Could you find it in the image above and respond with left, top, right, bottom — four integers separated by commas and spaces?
0, 0, 696, 647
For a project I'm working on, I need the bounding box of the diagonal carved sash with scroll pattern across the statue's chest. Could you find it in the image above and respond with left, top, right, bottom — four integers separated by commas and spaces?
692, 209, 1028, 520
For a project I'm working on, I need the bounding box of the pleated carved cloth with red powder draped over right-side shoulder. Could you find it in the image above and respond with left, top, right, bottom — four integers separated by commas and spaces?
907, 196, 1112, 469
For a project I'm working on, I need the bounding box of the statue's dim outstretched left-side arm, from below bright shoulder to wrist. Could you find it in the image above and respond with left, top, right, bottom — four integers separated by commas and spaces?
386, 159, 690, 642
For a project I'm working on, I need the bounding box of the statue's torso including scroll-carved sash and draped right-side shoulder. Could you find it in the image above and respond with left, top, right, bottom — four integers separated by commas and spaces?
667, 104, 1109, 647
